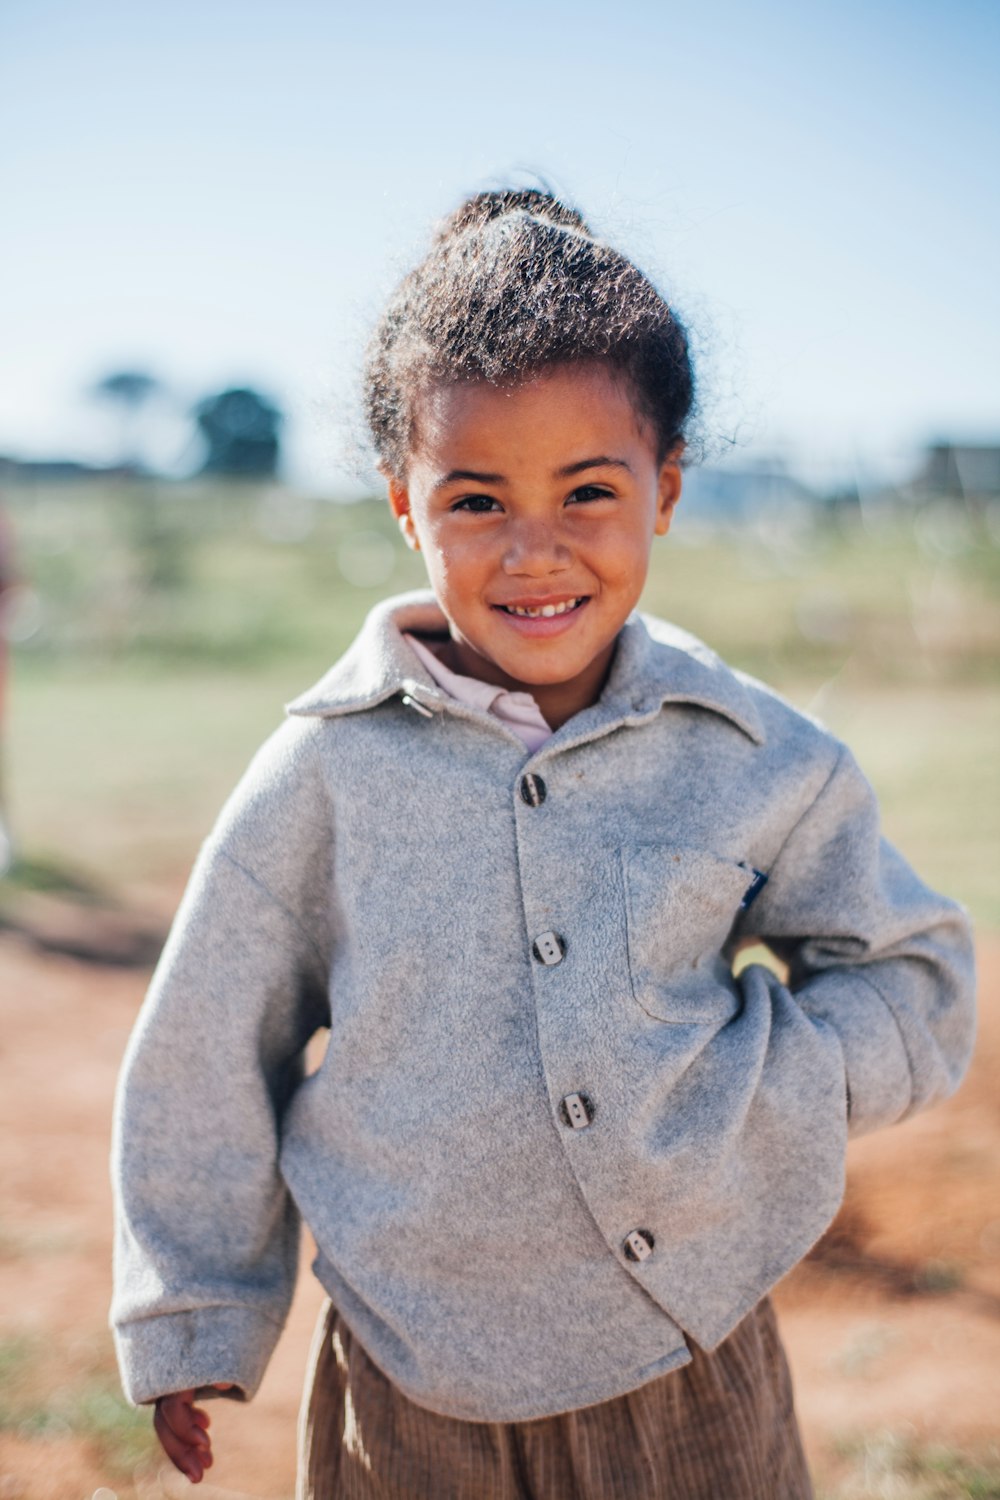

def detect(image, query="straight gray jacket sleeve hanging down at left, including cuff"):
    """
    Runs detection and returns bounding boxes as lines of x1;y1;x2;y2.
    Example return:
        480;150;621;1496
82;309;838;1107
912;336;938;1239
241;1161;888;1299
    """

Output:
111;726;331;1403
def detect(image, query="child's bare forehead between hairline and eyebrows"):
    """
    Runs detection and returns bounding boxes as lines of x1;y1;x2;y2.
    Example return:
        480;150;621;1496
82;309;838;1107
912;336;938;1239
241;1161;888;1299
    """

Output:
412;365;654;473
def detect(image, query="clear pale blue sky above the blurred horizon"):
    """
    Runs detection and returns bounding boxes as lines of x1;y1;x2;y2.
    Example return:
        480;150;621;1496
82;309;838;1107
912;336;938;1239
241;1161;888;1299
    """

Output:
0;0;1000;488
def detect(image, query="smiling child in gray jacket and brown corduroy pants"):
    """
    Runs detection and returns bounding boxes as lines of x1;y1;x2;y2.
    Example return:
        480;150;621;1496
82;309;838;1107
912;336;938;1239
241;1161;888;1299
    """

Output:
112;192;973;1500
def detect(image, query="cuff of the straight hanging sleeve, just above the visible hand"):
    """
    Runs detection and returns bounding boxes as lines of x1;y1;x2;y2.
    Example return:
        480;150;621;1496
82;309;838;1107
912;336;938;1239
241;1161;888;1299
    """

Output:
114;1307;282;1406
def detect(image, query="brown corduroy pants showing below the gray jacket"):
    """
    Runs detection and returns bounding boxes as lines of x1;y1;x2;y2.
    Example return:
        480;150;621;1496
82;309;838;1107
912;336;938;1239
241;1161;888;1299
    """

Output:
298;1298;813;1500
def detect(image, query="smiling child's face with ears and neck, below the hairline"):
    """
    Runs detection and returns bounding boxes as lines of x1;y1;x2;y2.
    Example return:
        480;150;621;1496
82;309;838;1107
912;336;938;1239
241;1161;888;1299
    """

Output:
390;365;681;728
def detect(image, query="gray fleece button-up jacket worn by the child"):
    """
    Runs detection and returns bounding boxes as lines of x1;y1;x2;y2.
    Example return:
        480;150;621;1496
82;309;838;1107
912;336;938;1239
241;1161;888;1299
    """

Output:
112;594;973;1421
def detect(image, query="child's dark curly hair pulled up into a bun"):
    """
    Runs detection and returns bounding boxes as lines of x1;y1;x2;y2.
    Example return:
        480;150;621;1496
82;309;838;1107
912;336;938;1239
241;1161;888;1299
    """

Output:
363;188;694;477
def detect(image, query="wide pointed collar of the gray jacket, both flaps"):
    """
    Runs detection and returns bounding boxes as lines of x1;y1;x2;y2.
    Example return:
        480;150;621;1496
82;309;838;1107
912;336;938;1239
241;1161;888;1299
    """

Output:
286;590;765;746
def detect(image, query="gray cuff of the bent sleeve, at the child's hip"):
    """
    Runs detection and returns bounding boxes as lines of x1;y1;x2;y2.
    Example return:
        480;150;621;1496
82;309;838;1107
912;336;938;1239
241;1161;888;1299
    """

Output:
795;968;913;1136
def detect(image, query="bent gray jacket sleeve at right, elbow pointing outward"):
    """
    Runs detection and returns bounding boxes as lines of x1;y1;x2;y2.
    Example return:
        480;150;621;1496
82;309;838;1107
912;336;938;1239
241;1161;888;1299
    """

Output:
744;747;975;1136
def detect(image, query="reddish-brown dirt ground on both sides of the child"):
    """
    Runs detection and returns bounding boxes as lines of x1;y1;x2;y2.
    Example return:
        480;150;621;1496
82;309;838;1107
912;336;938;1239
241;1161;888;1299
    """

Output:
0;912;1000;1500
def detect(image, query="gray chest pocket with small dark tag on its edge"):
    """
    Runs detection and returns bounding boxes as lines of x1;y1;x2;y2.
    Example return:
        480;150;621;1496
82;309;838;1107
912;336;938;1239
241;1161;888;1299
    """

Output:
622;845;754;1026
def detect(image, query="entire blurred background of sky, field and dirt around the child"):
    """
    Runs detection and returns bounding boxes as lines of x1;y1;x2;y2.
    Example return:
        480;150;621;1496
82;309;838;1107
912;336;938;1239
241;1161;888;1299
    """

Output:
0;0;1000;1500
